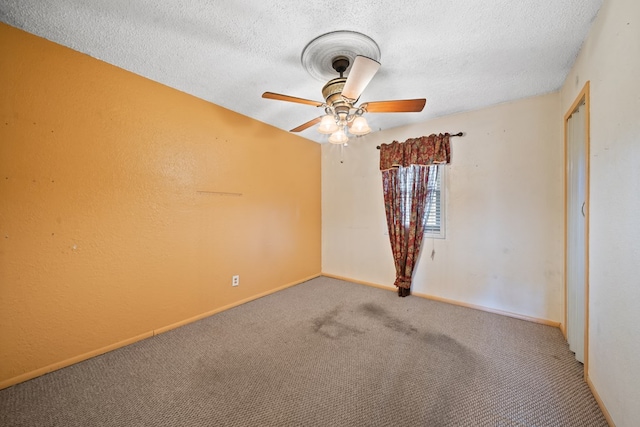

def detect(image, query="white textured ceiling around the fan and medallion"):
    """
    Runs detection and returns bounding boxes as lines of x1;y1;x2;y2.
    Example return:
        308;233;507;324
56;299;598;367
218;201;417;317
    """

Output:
0;0;603;142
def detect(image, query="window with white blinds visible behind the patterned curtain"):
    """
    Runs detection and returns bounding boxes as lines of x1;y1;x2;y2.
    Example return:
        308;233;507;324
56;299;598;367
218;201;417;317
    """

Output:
400;165;445;239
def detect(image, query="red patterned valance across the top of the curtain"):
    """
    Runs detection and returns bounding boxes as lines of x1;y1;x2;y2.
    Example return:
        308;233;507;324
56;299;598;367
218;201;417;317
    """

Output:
380;133;451;170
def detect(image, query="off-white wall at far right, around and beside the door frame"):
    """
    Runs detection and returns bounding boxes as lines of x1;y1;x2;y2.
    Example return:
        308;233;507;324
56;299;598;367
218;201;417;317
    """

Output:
561;0;640;427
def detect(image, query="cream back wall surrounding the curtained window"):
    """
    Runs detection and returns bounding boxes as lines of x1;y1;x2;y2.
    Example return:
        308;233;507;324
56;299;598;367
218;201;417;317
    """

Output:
322;93;564;322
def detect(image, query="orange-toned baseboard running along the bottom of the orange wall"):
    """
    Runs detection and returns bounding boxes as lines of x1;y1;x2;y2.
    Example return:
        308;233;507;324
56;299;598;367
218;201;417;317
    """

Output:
0;274;321;390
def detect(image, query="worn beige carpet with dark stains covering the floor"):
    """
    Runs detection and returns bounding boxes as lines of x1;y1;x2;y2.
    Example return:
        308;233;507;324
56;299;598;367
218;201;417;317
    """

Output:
0;278;607;427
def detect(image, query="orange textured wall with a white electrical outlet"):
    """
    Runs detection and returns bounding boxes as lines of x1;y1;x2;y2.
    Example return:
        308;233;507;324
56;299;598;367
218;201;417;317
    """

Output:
0;24;321;387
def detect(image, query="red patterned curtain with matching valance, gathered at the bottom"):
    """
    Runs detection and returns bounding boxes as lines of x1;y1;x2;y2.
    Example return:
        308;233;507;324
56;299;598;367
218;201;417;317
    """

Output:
380;133;451;297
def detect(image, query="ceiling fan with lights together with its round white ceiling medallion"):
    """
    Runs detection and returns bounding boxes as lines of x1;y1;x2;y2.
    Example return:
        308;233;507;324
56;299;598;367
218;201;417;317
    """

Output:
262;31;426;144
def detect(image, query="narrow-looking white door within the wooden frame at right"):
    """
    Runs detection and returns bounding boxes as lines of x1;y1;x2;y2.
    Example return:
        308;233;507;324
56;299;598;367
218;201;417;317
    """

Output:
566;102;587;363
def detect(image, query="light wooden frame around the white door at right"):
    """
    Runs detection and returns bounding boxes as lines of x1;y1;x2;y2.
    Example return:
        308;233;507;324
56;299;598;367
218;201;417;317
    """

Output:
562;81;591;381
